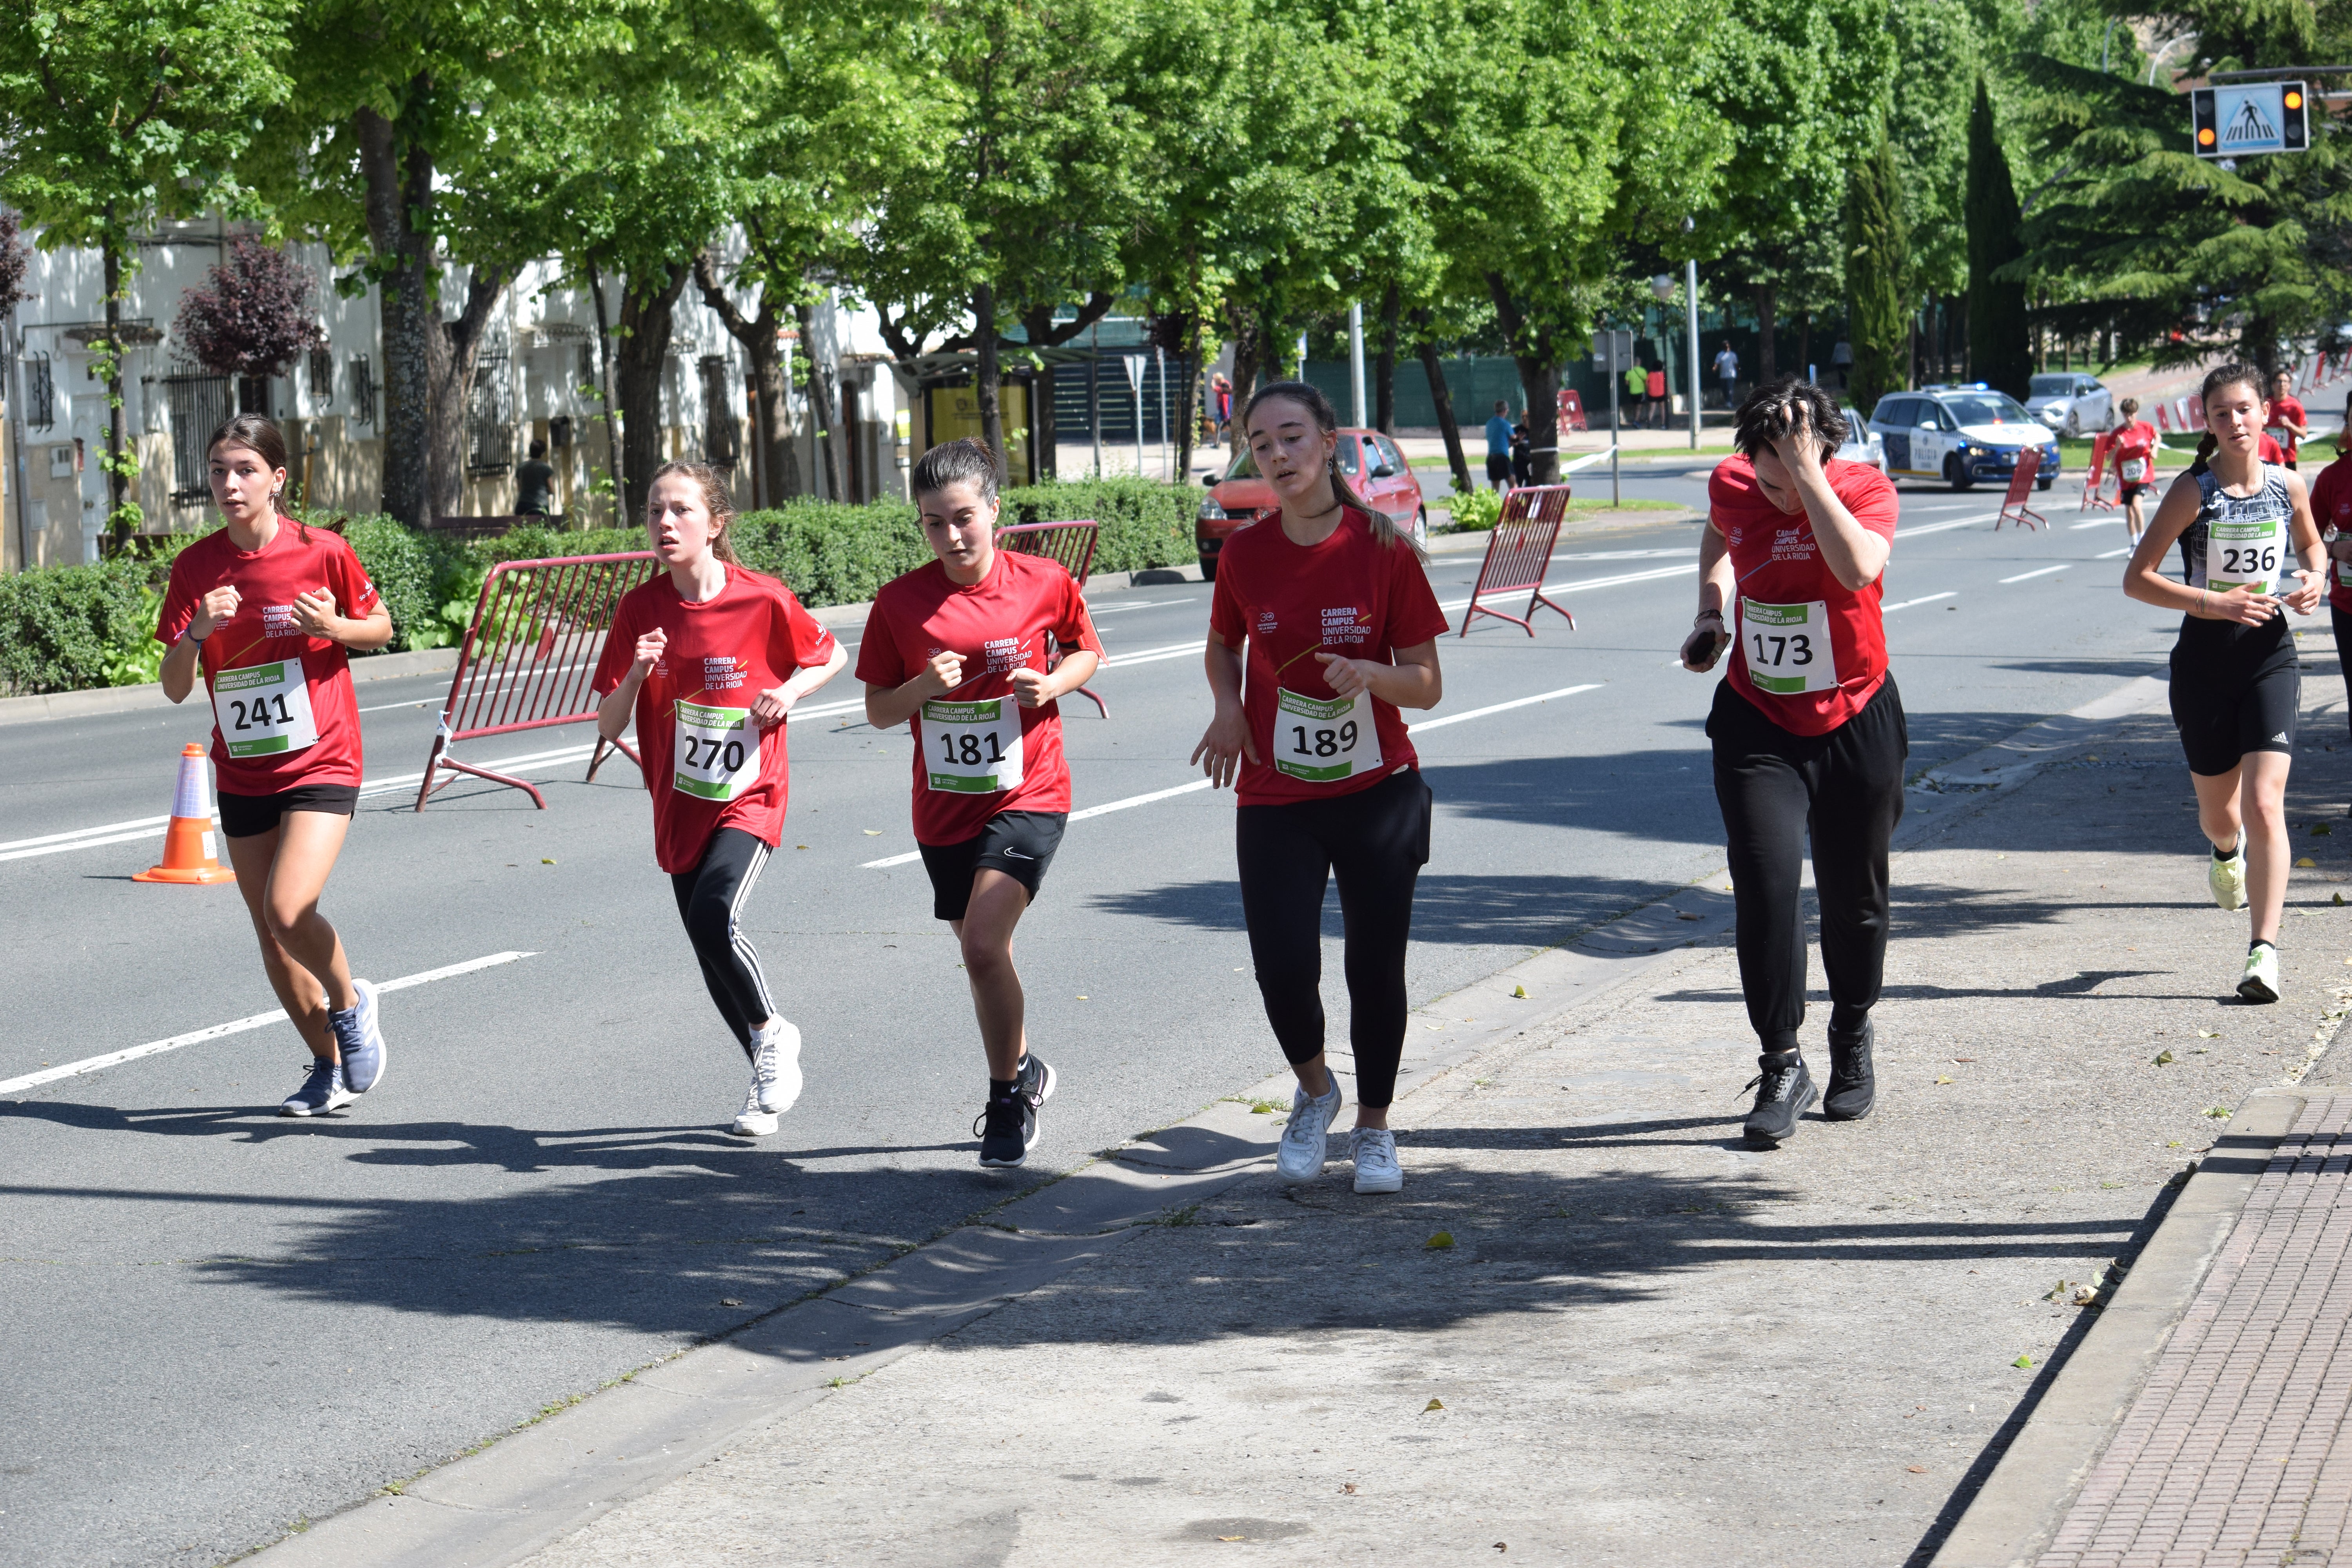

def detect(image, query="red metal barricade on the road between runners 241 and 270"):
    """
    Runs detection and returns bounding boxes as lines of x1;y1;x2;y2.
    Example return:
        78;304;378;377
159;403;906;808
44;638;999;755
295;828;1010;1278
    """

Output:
416;550;654;811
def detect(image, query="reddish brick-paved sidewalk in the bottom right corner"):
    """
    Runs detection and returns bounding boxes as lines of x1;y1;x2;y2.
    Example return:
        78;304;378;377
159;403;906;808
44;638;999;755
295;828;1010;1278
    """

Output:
2037;1096;2352;1568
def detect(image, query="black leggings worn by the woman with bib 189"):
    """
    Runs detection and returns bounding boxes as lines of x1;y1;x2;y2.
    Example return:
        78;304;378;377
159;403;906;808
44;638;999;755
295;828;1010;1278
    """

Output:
1232;769;1430;1110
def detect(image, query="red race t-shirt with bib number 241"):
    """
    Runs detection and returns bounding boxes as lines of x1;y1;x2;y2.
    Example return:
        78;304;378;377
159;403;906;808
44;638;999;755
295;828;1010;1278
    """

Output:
155;517;376;795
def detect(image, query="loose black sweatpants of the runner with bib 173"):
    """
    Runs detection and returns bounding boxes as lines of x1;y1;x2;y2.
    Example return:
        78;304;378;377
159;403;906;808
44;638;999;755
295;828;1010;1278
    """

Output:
1708;675;1910;1051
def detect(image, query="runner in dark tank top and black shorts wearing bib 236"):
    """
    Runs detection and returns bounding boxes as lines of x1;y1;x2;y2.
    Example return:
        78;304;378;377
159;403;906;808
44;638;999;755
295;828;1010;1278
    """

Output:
2124;365;2324;1002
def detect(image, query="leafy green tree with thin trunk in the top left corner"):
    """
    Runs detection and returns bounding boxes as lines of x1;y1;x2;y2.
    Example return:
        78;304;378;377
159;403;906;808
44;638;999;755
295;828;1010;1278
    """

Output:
0;0;287;538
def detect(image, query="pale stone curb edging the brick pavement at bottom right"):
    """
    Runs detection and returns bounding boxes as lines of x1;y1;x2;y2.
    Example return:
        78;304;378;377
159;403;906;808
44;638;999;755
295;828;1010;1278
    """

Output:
1931;1089;2305;1568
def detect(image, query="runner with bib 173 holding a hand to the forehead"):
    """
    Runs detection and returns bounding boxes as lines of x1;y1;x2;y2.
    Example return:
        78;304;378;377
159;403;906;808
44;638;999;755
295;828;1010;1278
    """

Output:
1682;376;1910;1145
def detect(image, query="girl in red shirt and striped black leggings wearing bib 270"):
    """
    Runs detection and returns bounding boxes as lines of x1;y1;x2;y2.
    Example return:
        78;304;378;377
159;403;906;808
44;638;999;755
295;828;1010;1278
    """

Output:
595;463;849;1138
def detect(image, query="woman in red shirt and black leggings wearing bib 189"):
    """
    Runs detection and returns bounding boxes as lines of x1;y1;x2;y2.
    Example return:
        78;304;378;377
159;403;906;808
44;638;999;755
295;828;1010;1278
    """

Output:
1192;381;1446;1192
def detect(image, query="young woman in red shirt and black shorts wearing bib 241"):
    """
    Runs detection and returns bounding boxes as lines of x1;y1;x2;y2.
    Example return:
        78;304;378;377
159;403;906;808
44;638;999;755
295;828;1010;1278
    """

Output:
155;414;393;1117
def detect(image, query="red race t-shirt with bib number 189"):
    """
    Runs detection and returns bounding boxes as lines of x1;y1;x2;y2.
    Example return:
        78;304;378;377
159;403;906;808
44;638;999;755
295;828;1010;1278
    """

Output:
1209;508;1446;806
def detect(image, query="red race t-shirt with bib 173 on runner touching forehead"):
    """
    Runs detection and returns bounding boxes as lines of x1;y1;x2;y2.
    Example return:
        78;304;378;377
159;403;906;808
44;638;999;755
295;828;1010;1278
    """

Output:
1708;456;1898;736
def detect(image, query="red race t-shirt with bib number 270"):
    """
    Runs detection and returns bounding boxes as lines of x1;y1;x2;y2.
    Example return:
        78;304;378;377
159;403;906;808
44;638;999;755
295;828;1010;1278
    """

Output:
595;566;833;872
